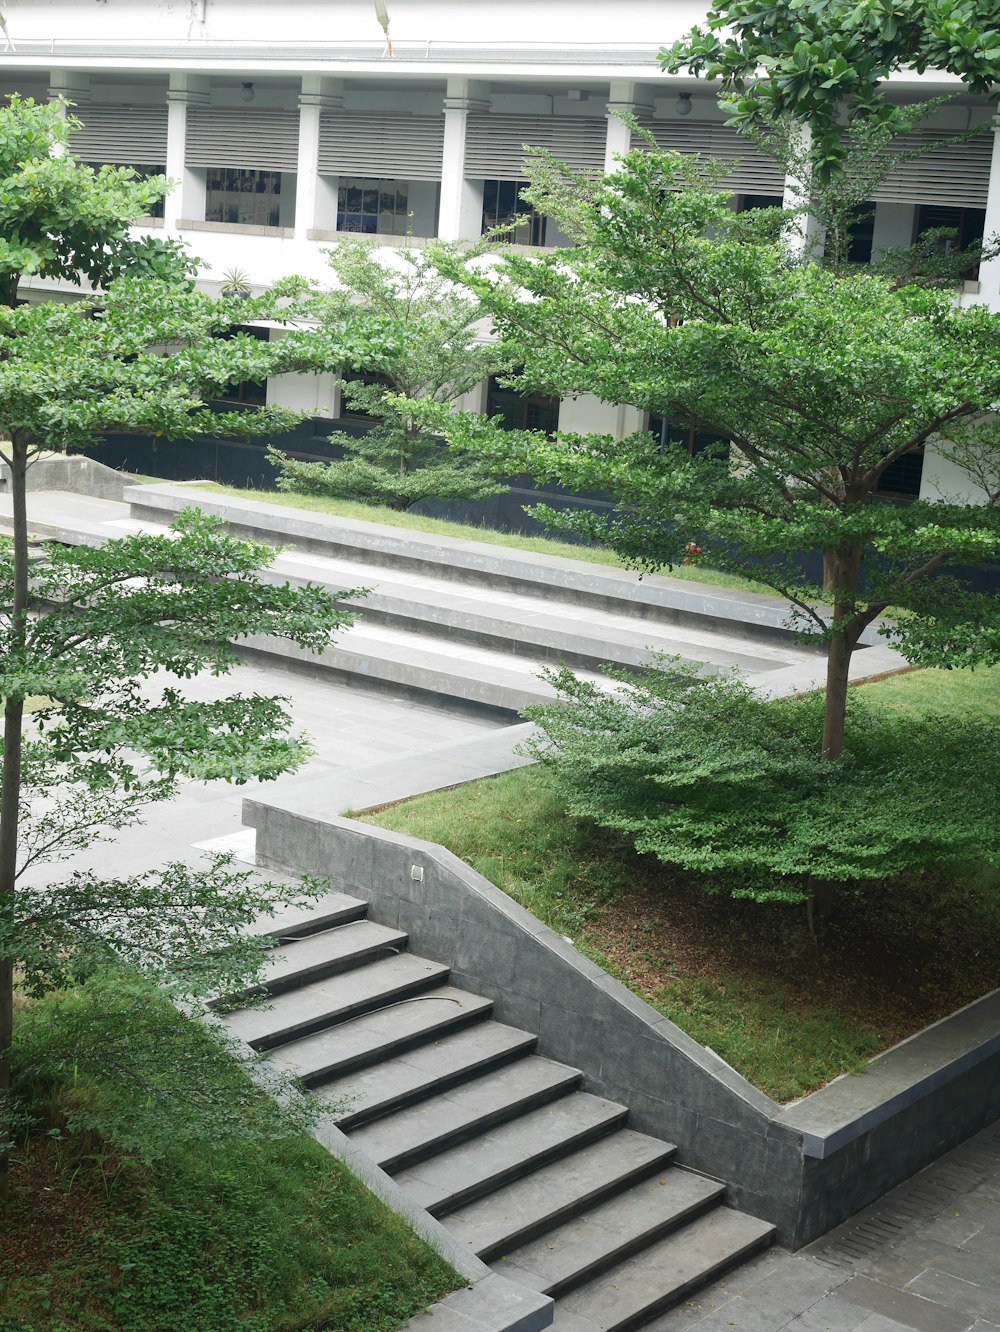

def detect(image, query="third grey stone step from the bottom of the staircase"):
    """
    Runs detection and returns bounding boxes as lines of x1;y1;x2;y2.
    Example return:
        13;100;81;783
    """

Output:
445;1128;676;1263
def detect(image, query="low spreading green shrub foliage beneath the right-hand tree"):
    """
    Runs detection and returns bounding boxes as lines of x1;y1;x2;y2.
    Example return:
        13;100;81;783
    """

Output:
519;662;1000;902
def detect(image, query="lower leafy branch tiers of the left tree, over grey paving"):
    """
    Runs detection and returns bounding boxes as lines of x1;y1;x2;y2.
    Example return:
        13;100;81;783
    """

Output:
0;510;358;872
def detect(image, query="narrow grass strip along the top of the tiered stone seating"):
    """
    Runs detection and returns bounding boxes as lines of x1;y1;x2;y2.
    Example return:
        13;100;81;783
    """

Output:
198;481;775;597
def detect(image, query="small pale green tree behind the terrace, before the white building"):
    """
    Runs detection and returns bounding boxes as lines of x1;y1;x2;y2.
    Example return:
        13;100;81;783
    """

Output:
269;240;507;509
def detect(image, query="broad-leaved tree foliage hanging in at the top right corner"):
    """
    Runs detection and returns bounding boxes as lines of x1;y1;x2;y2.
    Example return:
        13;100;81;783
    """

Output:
660;0;1000;181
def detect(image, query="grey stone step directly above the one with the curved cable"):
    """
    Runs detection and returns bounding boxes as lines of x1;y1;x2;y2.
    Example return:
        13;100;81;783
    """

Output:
224;952;449;1050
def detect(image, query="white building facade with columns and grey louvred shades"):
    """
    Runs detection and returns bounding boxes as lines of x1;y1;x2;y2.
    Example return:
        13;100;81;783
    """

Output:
0;0;1000;496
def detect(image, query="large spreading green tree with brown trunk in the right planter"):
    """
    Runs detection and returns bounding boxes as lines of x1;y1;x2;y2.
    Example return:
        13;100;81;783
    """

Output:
425;152;1000;759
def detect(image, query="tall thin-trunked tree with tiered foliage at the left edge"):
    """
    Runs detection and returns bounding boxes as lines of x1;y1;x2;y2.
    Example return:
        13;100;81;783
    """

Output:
0;99;375;1198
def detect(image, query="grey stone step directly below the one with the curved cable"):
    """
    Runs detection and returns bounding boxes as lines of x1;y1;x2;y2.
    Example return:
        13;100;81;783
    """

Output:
317;1022;538;1131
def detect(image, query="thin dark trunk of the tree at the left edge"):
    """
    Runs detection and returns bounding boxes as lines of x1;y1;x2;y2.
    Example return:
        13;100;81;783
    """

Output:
0;436;28;1200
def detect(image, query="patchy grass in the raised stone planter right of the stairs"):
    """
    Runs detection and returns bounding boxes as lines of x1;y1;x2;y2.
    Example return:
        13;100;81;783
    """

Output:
365;669;1000;1100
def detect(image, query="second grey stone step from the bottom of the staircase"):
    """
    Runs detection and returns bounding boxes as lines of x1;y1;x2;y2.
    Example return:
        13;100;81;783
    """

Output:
494;1167;726;1299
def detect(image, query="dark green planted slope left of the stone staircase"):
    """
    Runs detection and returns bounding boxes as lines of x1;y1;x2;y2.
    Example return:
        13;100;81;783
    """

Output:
0;972;461;1332
